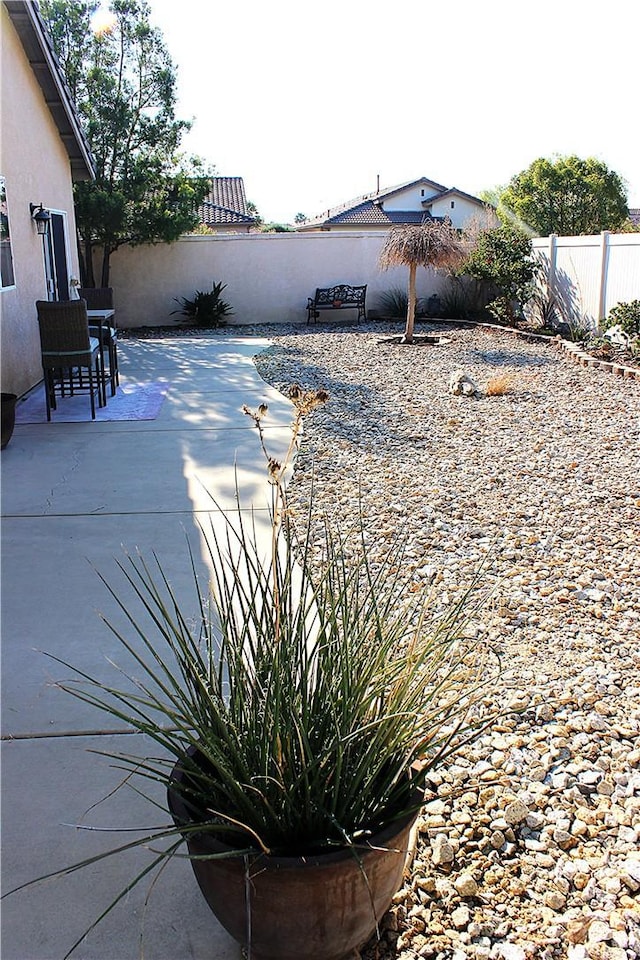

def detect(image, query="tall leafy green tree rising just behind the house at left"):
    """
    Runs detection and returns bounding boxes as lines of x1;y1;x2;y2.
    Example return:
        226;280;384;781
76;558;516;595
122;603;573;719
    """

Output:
40;0;211;286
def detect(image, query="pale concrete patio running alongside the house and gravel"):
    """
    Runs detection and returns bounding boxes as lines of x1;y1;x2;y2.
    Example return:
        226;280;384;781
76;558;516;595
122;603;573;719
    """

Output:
2;336;292;960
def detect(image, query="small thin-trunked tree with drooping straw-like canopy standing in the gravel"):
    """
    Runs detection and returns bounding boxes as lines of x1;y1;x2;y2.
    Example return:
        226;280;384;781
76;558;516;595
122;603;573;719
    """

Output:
378;220;465;343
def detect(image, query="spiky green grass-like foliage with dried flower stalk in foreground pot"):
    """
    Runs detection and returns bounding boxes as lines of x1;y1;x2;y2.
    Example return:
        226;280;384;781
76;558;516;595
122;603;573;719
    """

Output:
6;387;498;952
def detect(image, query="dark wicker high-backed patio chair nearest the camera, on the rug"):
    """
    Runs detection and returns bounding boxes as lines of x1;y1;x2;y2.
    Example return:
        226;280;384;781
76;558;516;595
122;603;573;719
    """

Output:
36;300;107;420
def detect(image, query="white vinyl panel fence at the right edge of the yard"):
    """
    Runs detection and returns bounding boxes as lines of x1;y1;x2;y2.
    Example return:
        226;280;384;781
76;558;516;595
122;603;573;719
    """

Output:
533;231;640;330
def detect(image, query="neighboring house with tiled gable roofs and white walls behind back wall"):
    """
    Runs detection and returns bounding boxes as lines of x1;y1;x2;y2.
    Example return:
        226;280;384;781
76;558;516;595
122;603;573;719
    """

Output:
296;177;498;232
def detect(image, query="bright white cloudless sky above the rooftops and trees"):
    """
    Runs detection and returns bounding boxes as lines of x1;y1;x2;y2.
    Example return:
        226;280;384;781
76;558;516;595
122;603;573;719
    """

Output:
142;0;640;223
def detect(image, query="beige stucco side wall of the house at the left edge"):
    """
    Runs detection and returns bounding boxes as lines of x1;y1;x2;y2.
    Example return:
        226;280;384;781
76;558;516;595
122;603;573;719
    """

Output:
0;4;78;395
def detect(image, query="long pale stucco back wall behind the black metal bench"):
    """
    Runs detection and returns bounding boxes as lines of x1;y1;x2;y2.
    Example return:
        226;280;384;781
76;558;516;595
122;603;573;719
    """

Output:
111;231;444;327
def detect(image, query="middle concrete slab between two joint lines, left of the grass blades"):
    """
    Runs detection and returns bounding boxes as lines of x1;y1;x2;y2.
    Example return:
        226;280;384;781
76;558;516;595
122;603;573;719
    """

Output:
2;513;268;737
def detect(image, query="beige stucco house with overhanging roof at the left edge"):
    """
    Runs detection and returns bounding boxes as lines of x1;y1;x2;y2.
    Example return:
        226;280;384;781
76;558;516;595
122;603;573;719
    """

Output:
0;0;94;395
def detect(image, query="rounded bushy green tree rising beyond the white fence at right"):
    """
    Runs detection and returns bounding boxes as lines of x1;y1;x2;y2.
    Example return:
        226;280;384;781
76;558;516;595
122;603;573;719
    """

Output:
498;156;629;236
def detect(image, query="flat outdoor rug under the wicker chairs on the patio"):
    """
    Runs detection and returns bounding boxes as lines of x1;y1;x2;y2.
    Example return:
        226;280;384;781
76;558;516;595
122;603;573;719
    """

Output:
16;383;168;423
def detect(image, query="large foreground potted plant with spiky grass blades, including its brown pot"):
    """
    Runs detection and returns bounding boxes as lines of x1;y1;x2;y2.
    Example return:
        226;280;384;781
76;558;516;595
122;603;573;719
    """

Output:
5;387;502;960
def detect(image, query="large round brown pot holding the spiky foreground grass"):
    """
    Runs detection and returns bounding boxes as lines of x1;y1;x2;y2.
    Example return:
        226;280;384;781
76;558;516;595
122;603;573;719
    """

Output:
168;752;417;960
